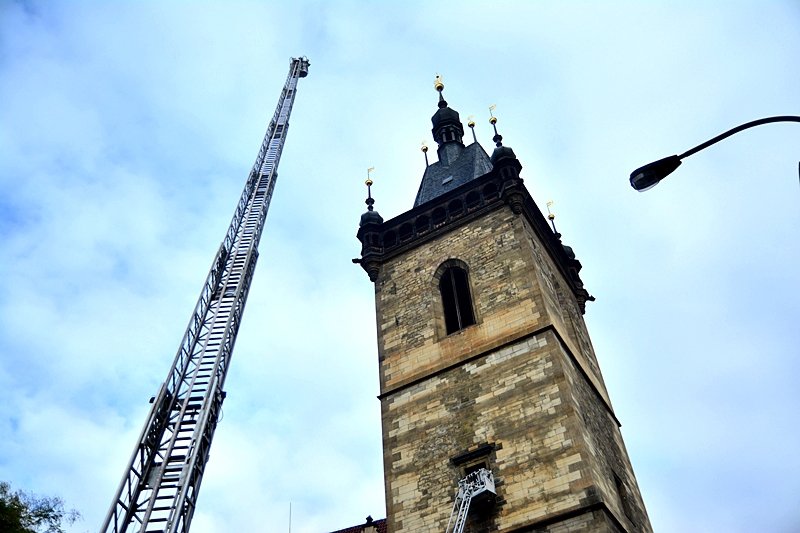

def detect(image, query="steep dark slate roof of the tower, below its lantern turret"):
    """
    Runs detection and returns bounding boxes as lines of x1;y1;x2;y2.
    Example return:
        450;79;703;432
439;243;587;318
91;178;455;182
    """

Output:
414;142;492;207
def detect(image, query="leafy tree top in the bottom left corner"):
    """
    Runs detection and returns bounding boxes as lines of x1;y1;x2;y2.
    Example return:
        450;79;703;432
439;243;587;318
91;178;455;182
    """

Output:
0;481;80;533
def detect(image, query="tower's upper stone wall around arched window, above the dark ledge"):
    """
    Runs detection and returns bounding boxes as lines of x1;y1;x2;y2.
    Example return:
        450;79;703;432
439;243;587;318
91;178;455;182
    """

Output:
375;207;608;403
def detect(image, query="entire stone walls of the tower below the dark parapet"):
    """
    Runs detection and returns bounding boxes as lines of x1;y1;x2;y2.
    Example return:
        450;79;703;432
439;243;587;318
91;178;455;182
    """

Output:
375;203;649;533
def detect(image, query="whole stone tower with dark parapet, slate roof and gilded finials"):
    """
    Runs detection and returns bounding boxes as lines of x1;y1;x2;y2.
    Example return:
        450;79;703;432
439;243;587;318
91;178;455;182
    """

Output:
354;80;652;533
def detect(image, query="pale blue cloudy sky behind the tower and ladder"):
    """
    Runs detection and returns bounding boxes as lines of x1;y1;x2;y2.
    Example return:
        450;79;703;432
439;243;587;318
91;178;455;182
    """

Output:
0;0;800;533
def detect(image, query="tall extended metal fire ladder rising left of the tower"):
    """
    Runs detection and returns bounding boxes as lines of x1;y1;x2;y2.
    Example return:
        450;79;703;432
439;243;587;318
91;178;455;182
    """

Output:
101;57;310;533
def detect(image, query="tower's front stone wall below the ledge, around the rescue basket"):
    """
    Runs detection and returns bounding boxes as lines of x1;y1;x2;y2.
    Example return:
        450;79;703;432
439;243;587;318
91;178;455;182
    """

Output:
382;335;591;533
